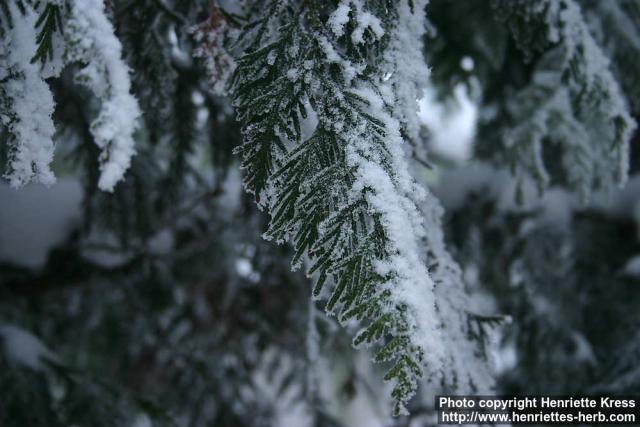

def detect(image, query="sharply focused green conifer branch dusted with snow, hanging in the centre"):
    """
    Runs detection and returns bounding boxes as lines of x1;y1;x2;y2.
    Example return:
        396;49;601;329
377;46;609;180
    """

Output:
225;1;450;413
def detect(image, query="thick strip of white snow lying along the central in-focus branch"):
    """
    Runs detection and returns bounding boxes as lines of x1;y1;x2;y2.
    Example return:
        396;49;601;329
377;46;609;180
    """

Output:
345;82;443;371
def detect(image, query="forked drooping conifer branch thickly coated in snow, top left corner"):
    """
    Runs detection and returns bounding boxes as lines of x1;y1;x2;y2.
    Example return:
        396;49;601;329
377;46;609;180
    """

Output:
1;0;140;191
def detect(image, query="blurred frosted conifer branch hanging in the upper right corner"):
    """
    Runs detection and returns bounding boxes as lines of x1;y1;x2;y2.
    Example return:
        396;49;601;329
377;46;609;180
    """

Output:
494;0;636;199
